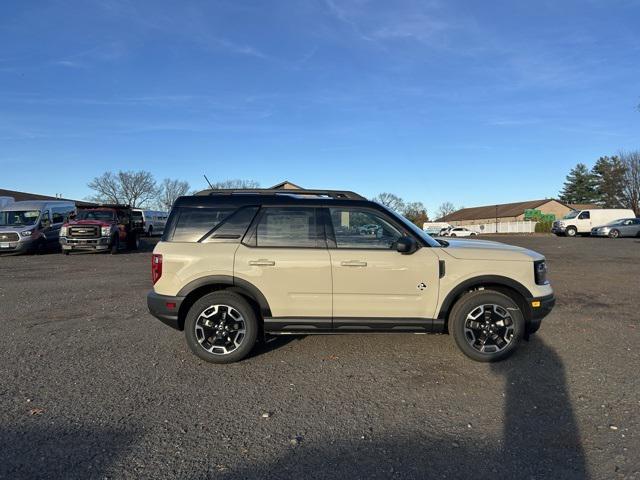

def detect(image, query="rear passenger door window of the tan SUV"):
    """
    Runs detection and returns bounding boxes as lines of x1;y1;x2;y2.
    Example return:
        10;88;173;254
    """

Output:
256;207;319;247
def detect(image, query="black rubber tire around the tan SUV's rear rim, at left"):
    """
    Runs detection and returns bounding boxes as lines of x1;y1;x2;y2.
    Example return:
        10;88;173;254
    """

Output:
184;290;258;363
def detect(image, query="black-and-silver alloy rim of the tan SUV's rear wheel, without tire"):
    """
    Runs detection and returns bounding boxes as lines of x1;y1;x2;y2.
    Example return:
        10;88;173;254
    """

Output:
195;305;247;355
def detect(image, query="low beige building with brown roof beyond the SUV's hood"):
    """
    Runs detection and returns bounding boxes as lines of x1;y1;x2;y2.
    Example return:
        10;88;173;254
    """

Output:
438;198;584;226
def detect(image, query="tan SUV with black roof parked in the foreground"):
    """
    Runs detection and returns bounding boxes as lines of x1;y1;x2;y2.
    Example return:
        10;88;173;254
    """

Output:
147;190;555;363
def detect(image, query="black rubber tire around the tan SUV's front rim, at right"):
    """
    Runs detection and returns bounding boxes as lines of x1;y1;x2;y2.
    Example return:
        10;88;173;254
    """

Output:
448;290;525;362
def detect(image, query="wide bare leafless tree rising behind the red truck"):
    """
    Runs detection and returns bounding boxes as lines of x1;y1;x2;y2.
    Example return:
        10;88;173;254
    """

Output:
88;170;158;207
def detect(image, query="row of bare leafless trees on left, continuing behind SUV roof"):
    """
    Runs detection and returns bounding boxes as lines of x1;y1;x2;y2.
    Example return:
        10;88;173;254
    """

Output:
87;170;260;211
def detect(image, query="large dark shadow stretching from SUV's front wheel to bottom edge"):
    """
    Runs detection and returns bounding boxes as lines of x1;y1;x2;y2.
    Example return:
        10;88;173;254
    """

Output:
222;338;589;480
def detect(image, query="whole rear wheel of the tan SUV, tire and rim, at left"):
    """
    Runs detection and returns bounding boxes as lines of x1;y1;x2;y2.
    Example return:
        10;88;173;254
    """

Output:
184;291;258;363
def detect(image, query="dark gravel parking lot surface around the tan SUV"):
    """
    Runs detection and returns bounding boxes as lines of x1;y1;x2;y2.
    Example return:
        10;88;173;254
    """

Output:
0;236;640;479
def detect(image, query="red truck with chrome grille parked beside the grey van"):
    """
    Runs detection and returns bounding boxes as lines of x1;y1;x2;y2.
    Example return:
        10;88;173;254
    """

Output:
60;205;142;255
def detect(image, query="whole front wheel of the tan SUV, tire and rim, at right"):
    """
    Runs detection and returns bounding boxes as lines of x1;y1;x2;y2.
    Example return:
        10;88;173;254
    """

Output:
449;290;525;362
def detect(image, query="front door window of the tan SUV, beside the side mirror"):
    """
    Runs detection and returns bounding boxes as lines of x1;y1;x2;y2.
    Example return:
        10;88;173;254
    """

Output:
329;208;402;249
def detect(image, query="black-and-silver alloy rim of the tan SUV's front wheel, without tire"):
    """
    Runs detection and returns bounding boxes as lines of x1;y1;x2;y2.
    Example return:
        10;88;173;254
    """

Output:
464;304;515;353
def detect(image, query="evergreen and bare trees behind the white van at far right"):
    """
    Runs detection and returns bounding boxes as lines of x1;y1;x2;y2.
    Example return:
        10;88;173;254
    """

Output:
559;150;640;215
